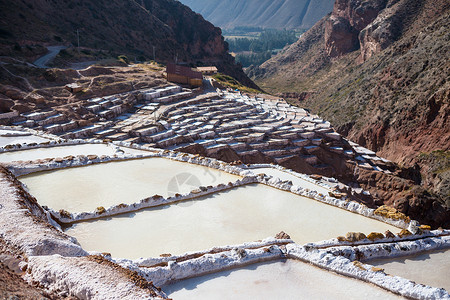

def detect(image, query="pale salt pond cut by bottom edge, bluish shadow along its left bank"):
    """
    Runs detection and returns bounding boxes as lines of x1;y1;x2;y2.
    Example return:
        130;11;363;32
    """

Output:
162;260;400;300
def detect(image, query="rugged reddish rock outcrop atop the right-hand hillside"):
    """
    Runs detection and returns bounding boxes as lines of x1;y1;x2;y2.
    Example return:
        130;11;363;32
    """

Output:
325;0;446;63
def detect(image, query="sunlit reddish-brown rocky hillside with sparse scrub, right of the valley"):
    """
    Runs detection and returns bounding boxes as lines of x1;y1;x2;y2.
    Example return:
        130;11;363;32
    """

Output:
248;0;450;226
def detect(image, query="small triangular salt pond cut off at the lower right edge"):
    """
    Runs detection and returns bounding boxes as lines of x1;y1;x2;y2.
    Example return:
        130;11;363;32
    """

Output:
367;250;450;291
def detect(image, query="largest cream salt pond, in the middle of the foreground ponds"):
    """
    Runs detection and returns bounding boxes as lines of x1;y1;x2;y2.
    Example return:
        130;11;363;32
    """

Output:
66;184;399;258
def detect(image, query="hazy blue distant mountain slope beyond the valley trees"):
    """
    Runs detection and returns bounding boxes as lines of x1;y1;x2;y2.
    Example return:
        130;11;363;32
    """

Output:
180;0;334;29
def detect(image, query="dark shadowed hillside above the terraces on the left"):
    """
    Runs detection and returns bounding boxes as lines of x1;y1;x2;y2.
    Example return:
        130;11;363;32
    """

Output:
0;0;251;84
